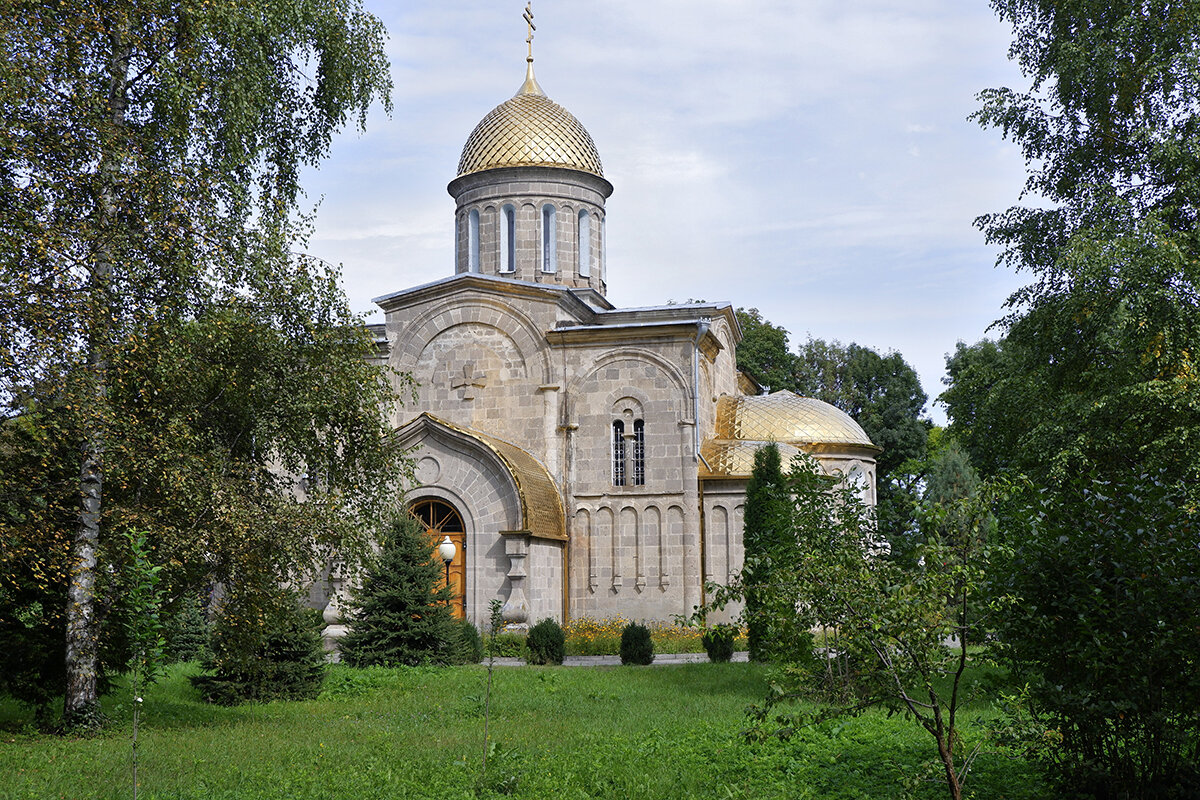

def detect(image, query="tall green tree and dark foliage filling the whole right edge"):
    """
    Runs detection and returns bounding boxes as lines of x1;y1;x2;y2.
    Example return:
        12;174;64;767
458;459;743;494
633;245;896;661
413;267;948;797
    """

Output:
960;6;1200;798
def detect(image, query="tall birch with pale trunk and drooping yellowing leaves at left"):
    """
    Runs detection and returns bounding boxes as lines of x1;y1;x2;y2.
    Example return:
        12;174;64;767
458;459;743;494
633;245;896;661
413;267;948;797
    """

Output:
0;0;400;724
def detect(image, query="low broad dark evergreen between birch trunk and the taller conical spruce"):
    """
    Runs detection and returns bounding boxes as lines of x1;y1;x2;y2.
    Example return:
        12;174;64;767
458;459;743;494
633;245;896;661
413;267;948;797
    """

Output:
192;587;325;705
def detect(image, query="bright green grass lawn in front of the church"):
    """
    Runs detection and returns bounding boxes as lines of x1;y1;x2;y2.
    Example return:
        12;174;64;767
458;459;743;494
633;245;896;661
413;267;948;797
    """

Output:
0;663;1049;800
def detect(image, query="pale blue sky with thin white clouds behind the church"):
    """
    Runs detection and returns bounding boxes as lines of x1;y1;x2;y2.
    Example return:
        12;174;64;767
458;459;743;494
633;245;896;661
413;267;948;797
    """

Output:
297;0;1028;423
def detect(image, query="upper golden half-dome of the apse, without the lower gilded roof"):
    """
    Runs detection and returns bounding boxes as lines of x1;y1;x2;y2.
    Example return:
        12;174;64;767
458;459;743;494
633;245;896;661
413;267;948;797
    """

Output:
715;391;875;447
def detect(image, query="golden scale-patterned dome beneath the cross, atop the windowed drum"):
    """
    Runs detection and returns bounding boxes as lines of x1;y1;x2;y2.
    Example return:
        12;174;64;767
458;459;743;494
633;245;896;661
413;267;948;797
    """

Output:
458;62;604;178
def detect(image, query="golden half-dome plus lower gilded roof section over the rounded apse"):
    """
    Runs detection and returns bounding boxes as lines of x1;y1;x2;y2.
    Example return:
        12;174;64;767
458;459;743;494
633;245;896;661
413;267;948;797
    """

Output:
701;391;880;477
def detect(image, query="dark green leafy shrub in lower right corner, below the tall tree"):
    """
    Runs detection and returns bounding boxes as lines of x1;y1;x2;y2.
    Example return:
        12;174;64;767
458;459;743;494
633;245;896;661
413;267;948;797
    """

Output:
998;475;1200;799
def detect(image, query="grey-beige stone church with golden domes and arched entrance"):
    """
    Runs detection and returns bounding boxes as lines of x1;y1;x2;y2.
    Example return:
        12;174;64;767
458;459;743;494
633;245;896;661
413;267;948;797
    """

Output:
326;43;878;624
